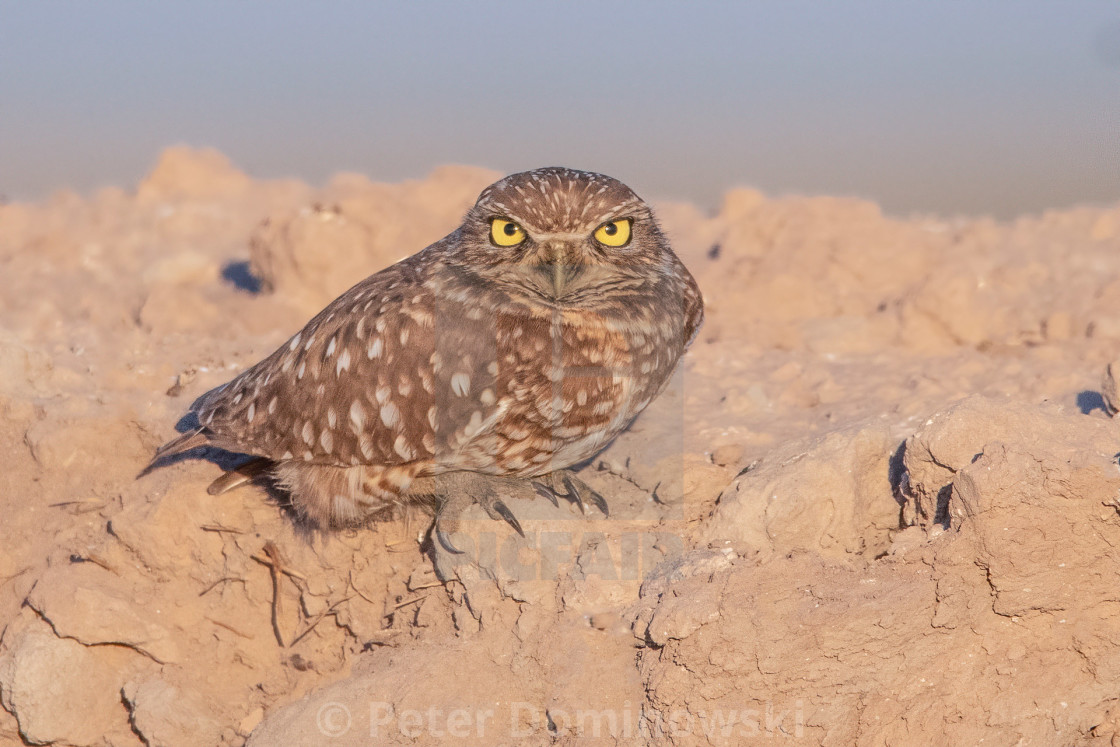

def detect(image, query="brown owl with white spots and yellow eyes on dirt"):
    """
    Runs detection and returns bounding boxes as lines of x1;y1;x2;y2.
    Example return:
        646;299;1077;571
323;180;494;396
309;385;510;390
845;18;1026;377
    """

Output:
153;168;703;539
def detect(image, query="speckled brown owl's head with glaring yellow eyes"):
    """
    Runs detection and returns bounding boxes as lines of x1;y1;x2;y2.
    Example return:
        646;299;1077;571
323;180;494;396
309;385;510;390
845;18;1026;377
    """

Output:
448;167;675;302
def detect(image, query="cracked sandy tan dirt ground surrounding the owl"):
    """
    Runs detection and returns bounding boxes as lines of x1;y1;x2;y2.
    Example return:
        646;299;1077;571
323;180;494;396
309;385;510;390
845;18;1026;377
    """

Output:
0;149;1120;747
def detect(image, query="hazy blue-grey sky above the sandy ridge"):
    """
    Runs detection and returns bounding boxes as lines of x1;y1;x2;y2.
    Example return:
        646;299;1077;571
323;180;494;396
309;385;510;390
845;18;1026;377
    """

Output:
0;0;1120;216
